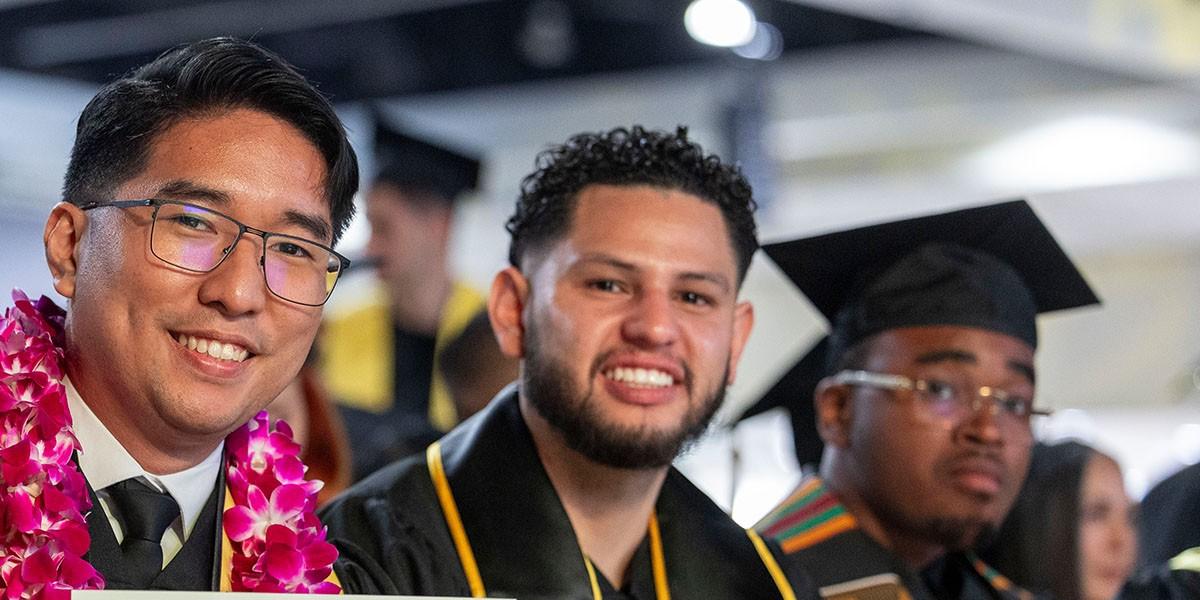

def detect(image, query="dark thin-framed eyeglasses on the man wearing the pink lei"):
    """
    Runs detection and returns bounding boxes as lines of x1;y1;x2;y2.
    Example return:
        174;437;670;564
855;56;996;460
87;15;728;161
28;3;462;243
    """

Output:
82;199;350;306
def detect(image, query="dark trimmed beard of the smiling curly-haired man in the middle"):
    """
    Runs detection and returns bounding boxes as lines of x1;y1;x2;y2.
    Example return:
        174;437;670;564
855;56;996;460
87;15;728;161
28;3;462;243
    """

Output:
521;324;728;469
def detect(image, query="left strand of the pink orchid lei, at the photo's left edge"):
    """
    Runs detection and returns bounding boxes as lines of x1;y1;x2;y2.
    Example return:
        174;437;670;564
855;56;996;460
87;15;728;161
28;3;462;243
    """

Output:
0;290;104;599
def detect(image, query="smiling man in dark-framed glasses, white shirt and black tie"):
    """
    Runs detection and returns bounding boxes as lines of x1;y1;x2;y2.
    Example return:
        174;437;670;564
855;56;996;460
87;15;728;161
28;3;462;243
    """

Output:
15;38;358;592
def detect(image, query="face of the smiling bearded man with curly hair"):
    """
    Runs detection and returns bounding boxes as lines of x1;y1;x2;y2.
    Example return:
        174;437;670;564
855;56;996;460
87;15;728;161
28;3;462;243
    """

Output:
504;185;752;468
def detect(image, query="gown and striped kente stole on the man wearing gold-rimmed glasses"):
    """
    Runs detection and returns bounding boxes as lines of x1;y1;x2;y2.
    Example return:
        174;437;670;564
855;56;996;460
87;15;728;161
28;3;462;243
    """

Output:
755;476;1033;600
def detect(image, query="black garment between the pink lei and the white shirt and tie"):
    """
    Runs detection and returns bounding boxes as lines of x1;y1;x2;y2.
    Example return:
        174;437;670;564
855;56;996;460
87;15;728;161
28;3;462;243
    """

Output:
83;468;224;592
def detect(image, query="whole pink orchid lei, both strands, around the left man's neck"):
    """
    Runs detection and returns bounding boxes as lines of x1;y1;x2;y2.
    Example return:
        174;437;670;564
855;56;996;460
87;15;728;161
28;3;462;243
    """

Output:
0;290;341;600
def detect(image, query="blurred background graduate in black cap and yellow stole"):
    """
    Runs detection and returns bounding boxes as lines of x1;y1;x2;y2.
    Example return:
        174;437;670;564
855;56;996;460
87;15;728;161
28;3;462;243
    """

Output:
319;113;508;480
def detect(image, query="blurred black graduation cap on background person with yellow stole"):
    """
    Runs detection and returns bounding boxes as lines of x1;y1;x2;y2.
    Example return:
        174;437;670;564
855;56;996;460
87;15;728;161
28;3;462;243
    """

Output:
374;112;479;204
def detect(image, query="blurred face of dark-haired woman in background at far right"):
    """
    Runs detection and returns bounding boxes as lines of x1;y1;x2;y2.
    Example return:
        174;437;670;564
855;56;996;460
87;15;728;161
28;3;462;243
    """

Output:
1079;454;1138;600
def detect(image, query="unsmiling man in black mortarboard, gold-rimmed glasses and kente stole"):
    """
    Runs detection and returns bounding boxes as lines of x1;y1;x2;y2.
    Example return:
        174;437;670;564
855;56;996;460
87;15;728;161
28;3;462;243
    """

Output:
756;202;1098;599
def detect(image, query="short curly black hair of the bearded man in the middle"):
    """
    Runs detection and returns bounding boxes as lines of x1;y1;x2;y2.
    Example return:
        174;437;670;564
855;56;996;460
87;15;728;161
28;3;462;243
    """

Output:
506;125;758;284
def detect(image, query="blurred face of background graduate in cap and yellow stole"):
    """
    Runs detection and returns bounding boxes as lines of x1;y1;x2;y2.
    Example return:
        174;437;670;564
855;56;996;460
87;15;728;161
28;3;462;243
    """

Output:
366;182;451;298
